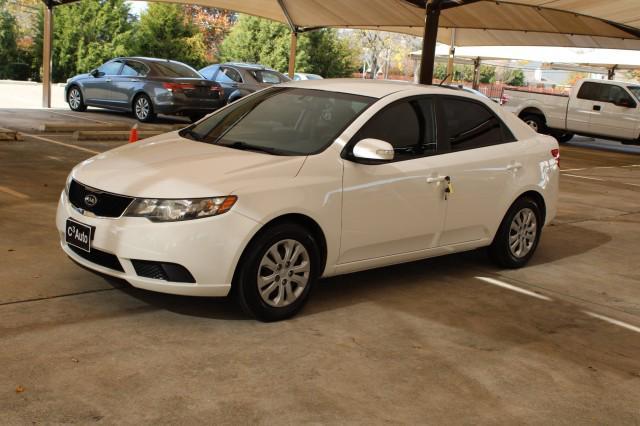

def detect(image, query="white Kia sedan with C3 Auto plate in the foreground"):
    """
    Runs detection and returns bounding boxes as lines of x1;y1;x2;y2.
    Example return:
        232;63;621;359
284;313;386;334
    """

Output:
56;80;559;321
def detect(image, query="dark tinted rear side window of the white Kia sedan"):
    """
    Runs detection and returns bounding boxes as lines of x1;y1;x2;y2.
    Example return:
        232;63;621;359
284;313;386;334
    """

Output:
442;97;515;152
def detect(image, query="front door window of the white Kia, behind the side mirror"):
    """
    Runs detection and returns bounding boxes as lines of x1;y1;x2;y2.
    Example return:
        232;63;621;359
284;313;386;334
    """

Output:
355;98;437;161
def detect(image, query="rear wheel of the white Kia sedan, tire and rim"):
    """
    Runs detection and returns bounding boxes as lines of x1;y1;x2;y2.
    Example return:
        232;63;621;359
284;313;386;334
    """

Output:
489;197;542;269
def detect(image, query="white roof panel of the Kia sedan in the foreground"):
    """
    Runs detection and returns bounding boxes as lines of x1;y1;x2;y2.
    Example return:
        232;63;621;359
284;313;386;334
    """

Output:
278;78;464;99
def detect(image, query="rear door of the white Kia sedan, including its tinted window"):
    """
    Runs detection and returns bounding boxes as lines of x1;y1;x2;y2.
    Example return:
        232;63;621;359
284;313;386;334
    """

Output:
438;96;526;246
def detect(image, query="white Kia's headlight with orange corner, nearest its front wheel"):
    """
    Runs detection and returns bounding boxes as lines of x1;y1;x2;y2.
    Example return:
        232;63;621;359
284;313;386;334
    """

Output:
124;195;238;222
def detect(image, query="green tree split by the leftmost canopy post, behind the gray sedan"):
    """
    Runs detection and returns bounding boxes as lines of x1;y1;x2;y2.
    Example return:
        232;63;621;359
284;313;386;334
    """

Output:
34;0;132;82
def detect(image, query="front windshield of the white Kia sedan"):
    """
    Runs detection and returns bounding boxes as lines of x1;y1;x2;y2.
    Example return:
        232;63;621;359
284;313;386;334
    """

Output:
181;87;375;155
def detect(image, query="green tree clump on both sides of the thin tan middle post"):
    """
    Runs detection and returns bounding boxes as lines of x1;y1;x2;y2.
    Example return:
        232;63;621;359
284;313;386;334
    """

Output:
220;15;355;77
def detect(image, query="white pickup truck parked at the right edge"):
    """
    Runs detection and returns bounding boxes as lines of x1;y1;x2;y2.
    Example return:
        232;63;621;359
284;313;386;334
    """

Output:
503;80;640;143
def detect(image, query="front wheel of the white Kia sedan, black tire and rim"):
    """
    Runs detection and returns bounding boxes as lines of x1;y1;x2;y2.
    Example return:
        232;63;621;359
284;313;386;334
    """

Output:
233;223;320;322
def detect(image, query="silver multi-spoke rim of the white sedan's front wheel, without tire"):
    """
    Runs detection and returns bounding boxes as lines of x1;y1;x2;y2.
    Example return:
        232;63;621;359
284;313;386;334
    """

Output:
257;239;311;308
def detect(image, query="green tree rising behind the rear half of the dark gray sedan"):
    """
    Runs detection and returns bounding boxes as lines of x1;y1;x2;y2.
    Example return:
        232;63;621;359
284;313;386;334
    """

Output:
132;3;207;68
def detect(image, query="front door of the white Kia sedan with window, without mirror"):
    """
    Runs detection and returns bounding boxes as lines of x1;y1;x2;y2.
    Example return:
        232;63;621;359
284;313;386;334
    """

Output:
339;97;446;264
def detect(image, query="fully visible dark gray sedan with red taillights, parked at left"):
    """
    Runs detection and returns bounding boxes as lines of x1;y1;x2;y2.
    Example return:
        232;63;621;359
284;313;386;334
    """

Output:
65;57;224;122
